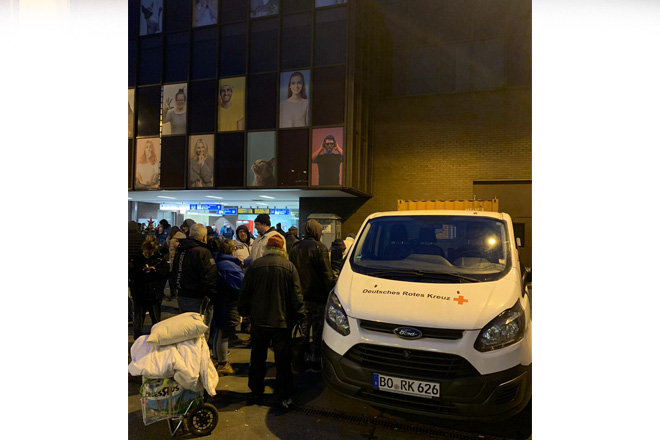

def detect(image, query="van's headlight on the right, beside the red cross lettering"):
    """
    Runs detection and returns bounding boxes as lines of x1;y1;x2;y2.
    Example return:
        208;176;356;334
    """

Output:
474;301;525;352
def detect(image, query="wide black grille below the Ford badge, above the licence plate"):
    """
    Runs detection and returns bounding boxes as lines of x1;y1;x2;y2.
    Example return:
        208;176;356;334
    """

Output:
346;344;479;380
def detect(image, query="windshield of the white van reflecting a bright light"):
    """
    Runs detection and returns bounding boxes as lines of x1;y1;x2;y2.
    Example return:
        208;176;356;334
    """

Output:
350;215;511;282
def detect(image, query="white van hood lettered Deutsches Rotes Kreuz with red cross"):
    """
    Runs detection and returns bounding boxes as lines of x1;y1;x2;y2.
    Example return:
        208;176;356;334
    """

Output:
335;270;520;330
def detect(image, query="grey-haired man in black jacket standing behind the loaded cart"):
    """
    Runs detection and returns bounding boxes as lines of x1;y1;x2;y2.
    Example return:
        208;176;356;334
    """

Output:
172;223;218;340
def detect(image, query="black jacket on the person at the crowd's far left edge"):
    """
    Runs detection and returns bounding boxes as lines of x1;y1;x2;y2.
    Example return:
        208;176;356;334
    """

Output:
128;253;169;301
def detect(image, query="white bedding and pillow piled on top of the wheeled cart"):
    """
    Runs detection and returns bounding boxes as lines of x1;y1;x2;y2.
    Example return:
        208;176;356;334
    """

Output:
128;312;218;396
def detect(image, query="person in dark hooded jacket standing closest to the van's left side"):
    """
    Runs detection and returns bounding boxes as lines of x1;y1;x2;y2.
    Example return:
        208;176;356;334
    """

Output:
289;220;335;373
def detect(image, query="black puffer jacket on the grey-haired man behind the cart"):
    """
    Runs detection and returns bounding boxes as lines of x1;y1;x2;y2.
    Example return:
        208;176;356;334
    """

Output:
172;238;218;300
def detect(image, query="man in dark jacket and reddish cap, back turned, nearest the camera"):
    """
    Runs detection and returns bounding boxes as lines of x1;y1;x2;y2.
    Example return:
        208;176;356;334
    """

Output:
238;234;305;408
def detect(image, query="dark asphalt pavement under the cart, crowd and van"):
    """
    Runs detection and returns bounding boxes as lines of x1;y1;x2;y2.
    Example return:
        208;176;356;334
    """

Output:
128;300;531;440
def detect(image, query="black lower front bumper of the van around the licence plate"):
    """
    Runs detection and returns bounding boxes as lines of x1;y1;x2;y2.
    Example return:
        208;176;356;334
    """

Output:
321;341;532;421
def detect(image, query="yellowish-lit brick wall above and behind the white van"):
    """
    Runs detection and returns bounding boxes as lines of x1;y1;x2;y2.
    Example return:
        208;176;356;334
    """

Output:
340;87;532;236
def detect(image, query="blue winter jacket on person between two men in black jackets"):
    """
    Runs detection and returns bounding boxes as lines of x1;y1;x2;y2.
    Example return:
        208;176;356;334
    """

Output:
213;253;243;328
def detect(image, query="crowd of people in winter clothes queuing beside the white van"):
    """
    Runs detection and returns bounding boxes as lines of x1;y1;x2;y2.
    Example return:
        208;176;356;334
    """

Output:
128;214;356;408
